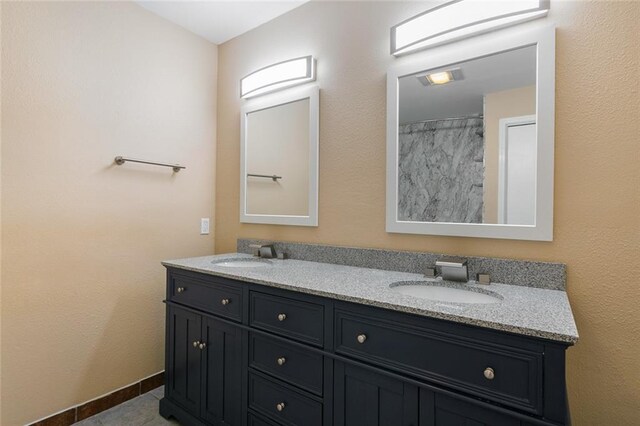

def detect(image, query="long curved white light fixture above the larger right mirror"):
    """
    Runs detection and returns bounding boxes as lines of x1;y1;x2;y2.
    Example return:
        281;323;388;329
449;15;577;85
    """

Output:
391;0;550;56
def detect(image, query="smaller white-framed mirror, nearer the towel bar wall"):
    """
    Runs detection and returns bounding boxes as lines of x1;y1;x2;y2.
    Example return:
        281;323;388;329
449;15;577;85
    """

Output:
240;86;319;226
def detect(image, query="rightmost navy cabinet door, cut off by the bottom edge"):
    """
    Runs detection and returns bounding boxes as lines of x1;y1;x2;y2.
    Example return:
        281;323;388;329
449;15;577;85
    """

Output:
420;389;523;426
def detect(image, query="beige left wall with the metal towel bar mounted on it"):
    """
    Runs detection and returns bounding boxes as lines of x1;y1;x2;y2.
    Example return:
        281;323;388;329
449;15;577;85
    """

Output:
0;2;218;426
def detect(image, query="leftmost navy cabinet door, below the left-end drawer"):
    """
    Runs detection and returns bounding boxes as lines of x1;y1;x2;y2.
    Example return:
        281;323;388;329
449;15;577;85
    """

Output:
165;306;202;413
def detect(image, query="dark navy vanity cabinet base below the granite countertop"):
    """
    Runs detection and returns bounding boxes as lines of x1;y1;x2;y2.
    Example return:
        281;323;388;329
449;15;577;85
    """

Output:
160;268;569;426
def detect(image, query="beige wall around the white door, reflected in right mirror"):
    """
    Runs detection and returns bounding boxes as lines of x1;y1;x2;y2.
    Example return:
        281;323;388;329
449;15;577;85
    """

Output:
483;86;536;223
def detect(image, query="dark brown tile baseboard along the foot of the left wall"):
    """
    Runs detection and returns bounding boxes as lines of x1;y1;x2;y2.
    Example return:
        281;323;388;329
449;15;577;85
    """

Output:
29;371;164;426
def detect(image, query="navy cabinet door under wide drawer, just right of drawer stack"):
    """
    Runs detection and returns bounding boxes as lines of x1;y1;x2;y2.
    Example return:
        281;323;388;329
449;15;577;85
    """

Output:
334;362;418;426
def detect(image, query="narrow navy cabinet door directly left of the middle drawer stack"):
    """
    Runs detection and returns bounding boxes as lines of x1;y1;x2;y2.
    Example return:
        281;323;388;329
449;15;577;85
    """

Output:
202;317;242;426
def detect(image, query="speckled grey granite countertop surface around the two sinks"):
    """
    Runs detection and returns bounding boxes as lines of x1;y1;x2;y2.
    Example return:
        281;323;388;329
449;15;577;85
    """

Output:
162;253;578;344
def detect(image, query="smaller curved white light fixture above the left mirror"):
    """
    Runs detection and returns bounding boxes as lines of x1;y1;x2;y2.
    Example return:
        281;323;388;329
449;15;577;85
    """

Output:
240;55;316;98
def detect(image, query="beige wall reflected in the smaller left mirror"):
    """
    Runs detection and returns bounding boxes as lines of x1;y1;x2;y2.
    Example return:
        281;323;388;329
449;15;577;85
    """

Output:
246;99;309;216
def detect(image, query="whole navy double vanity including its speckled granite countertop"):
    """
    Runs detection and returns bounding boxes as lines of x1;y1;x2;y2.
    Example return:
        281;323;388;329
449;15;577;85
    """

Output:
160;246;577;426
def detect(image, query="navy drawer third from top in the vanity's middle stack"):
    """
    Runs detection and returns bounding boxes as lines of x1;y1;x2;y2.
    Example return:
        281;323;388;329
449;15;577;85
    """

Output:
249;373;322;426
